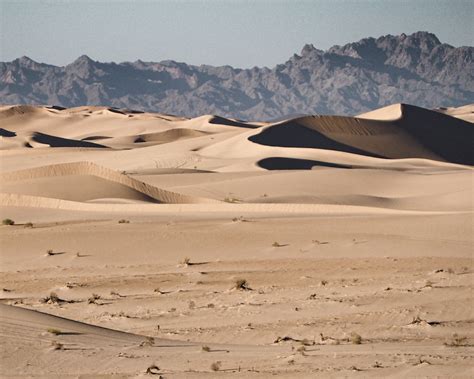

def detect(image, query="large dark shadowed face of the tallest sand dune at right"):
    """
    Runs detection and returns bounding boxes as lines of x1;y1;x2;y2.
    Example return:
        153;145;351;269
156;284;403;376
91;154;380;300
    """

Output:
248;104;474;165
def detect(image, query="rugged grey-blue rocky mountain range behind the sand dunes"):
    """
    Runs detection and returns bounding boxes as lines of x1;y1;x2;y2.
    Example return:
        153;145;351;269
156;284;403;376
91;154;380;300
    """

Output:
0;32;474;120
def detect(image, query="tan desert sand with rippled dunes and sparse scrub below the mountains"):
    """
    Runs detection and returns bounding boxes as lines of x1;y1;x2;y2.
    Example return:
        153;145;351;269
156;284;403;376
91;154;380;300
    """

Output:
0;104;474;378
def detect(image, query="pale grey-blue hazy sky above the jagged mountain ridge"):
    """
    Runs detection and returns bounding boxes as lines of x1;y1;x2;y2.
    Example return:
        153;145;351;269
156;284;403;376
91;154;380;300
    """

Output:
0;0;474;67
